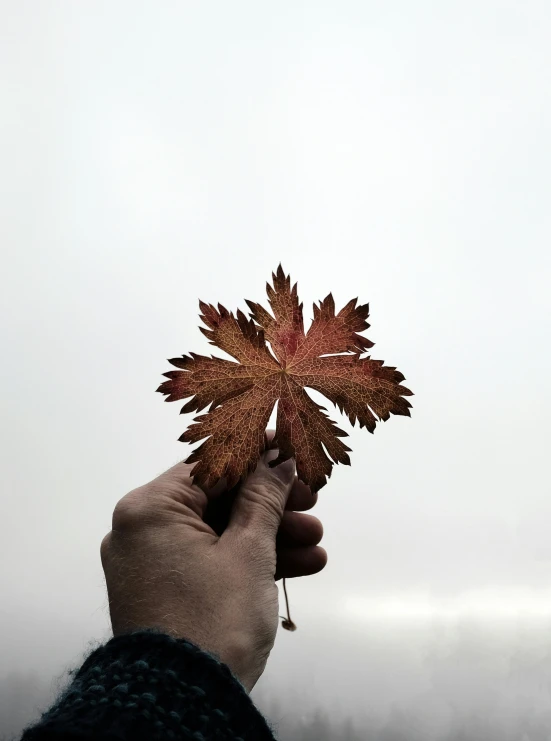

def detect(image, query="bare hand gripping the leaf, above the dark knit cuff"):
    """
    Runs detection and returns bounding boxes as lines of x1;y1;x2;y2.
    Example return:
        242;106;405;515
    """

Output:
101;442;327;692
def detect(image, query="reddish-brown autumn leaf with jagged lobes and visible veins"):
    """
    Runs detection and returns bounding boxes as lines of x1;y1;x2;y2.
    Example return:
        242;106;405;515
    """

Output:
157;265;412;491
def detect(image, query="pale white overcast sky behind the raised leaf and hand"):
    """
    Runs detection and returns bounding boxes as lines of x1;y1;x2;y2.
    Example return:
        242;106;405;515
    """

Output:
0;0;551;736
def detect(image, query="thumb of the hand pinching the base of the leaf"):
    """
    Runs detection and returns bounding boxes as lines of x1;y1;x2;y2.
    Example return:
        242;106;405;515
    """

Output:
227;450;296;540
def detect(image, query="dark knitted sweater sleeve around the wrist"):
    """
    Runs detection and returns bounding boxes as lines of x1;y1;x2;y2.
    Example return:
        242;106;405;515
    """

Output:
21;630;274;741
